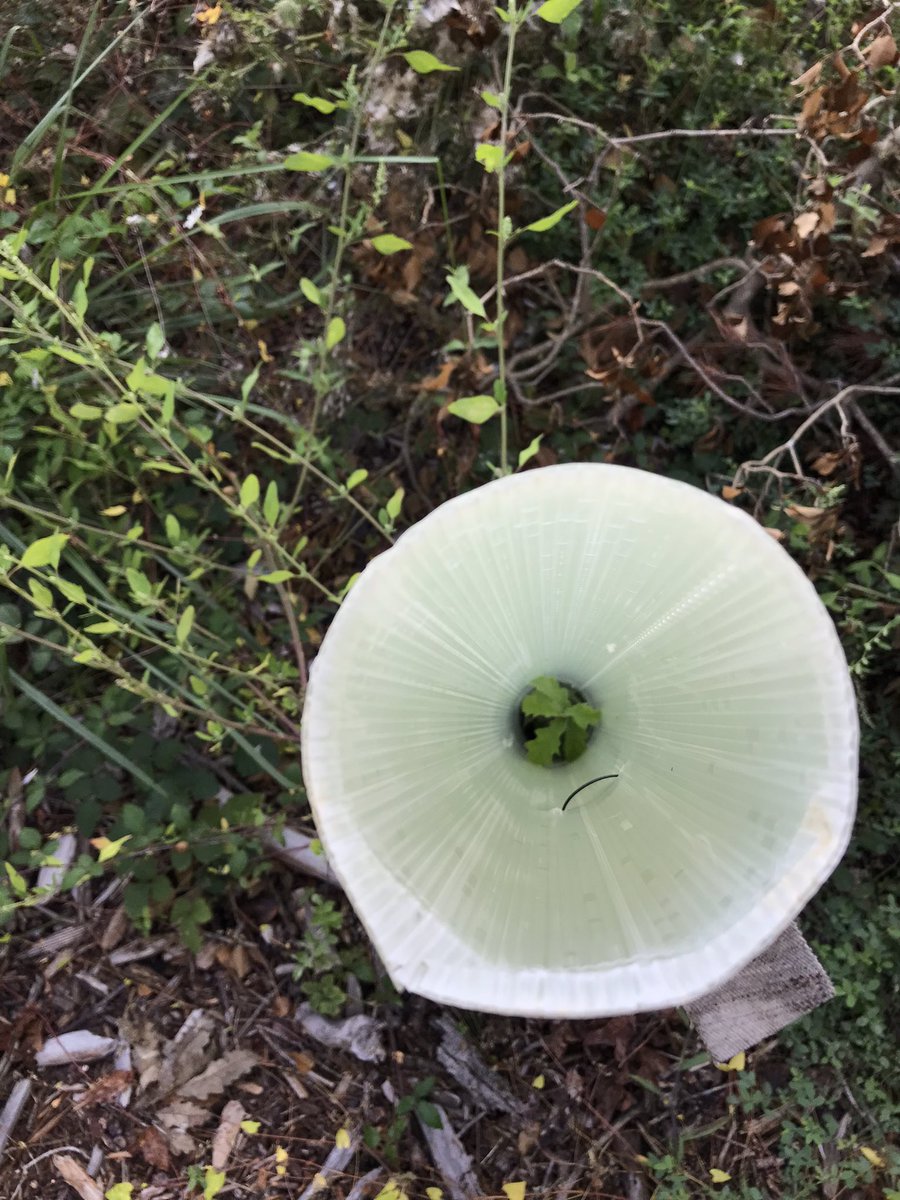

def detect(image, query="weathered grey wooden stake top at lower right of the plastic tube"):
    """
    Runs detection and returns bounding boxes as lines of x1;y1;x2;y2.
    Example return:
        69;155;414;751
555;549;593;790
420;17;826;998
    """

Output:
685;925;834;1062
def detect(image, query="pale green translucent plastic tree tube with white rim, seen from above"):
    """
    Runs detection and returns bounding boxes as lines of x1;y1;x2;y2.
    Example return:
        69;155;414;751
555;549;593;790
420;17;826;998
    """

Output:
302;464;858;1016
